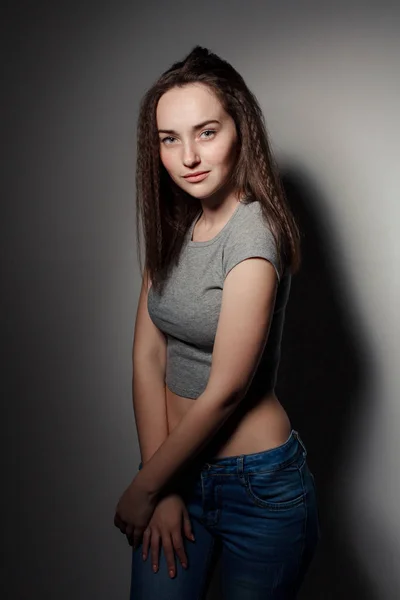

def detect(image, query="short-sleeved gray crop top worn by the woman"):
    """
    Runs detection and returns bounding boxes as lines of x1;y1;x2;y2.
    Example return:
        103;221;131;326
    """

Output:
147;200;291;398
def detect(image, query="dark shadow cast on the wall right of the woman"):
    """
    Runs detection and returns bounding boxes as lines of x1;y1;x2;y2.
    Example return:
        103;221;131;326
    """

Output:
207;170;377;600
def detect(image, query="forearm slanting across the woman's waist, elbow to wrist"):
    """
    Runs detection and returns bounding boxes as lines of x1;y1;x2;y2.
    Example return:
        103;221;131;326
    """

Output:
136;389;239;495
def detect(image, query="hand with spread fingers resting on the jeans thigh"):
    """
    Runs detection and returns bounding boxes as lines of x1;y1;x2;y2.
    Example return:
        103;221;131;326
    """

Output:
142;493;194;577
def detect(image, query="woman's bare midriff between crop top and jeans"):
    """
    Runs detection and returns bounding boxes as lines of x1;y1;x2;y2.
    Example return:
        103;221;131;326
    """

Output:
165;386;292;458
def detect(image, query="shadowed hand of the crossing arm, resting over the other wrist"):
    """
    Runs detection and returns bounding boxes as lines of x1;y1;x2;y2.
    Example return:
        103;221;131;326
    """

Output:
114;479;158;547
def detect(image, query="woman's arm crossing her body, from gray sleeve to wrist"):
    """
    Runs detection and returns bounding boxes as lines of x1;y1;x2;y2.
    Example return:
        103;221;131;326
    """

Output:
136;258;277;495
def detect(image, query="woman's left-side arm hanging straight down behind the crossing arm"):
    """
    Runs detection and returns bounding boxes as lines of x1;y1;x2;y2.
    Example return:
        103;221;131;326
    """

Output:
132;269;168;465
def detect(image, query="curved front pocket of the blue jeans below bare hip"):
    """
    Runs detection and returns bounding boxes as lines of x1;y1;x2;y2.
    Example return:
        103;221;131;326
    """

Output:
245;463;306;510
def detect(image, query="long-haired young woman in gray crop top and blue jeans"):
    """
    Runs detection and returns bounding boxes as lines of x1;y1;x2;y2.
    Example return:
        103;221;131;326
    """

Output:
114;46;320;600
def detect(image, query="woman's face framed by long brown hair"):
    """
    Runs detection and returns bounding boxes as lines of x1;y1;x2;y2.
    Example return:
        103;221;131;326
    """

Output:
156;83;238;198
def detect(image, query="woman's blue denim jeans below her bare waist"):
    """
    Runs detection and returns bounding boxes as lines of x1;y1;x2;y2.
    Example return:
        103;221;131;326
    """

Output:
130;429;320;600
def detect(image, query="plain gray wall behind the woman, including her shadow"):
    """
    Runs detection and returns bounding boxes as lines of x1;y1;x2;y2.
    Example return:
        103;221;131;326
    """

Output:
0;0;400;600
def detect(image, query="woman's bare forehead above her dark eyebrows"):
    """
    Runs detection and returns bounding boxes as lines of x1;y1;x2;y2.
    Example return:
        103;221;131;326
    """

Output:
156;84;225;129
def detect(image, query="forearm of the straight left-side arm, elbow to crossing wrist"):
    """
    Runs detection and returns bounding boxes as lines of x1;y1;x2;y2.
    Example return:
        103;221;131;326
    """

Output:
132;358;168;465
